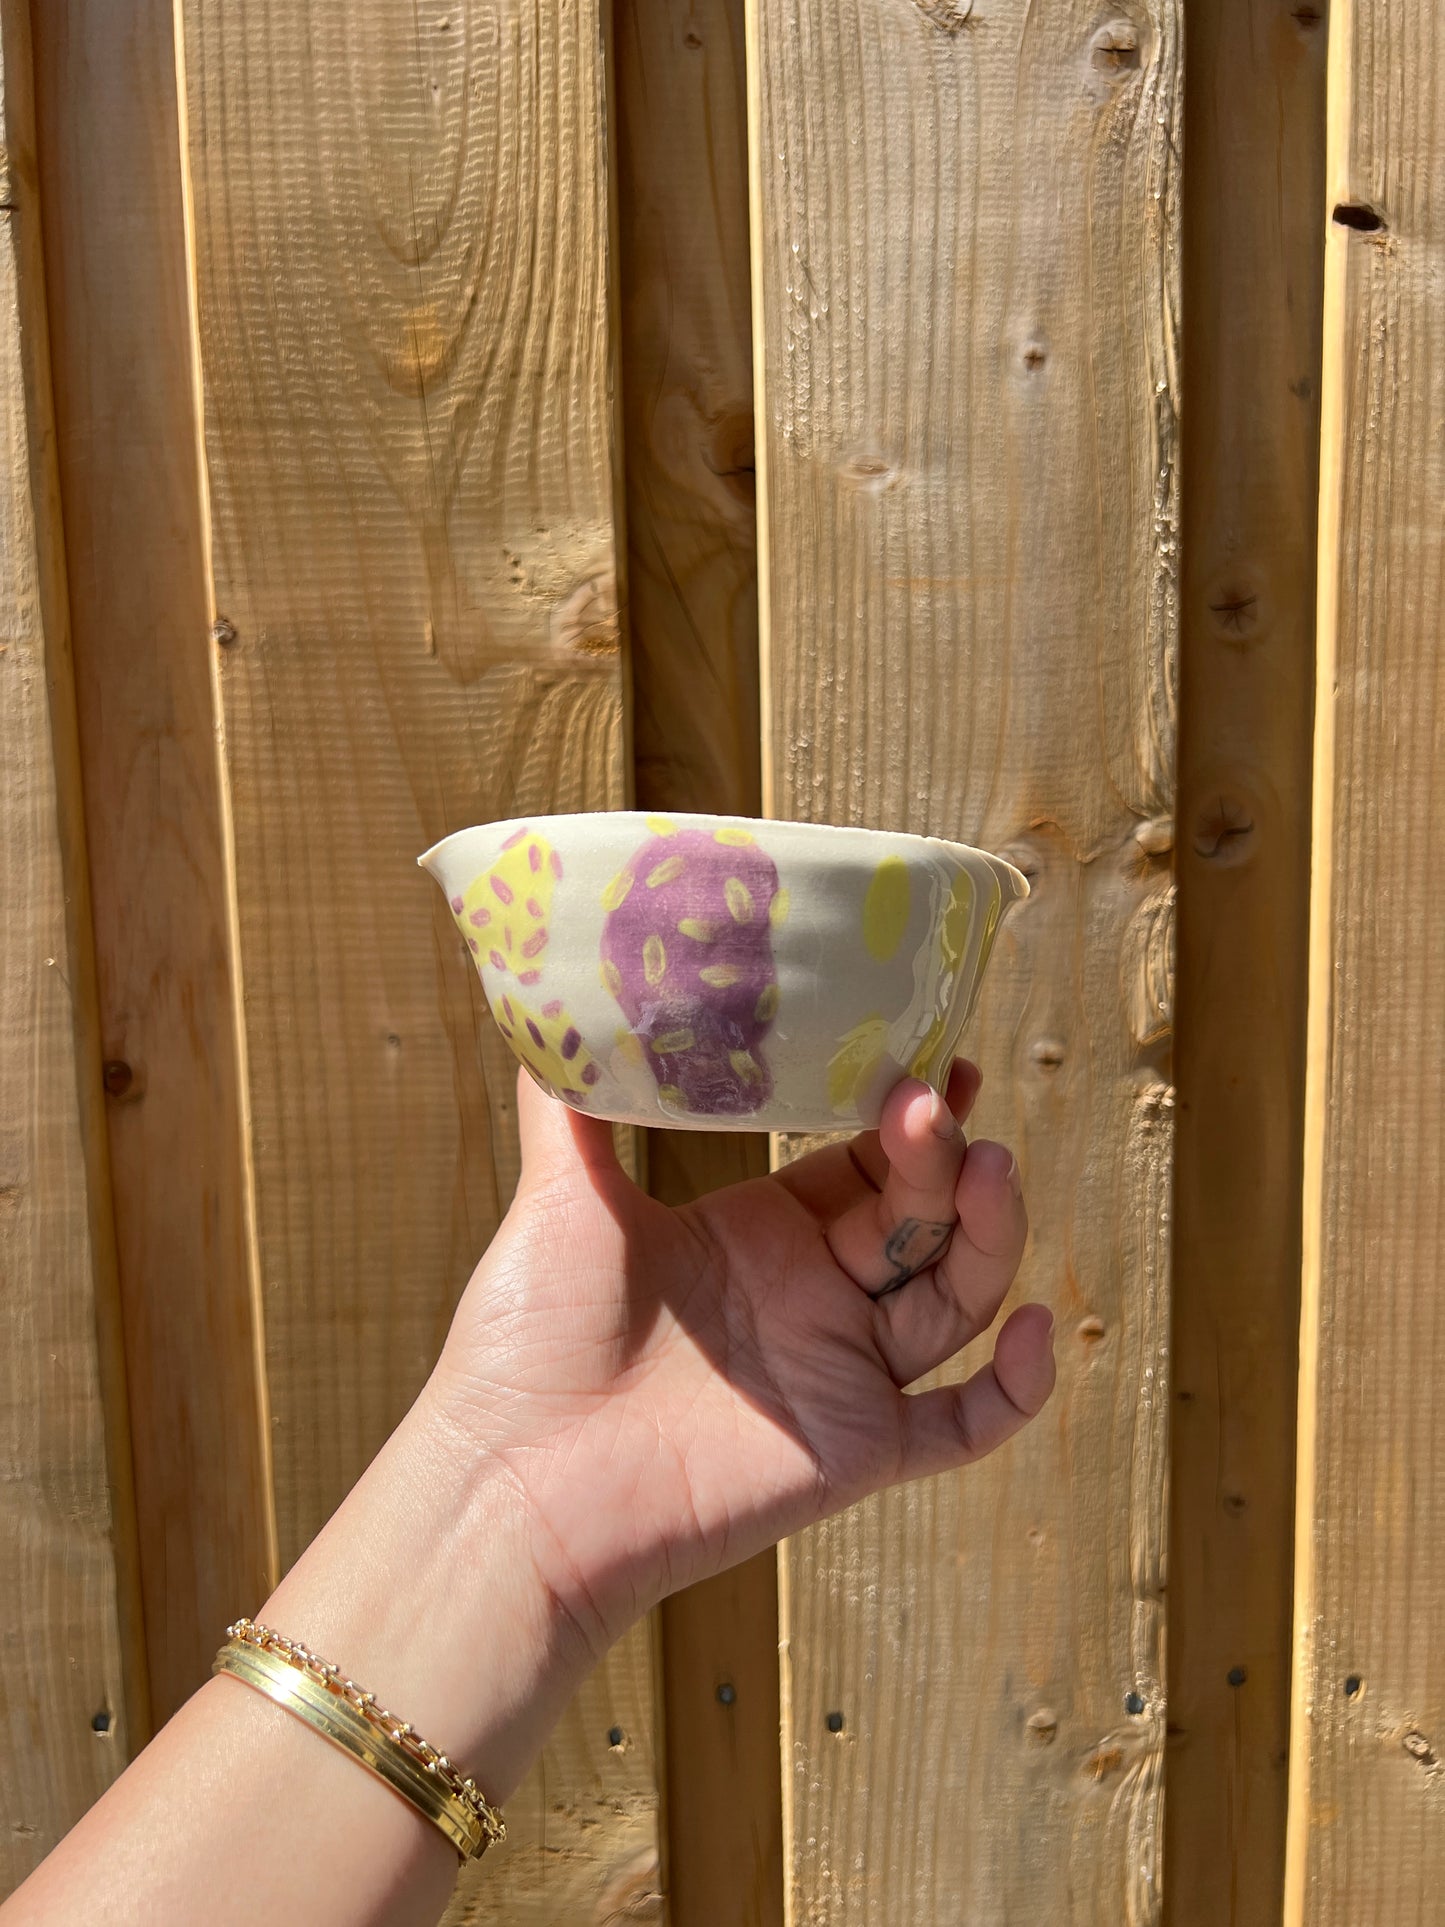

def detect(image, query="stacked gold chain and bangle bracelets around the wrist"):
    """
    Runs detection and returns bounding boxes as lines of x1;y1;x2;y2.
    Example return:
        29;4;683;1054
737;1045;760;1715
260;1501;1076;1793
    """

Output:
210;1619;507;1860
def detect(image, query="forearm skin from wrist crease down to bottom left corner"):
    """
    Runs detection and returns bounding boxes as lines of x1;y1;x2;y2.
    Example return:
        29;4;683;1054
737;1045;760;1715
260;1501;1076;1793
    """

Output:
4;1395;593;1927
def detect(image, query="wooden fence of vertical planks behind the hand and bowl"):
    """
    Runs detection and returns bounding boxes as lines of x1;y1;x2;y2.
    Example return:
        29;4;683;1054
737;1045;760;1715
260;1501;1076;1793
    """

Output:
0;0;1445;1927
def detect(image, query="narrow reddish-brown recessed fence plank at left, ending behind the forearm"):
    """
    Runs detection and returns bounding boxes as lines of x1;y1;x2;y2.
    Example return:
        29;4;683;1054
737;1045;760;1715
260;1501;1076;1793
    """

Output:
35;0;276;1721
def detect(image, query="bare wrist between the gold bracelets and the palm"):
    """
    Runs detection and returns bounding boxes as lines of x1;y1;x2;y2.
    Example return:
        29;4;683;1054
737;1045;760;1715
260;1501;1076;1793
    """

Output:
256;1393;597;1804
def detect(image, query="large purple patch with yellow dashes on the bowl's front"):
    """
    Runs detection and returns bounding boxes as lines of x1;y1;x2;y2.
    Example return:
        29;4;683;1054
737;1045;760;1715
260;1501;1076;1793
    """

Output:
601;831;778;1118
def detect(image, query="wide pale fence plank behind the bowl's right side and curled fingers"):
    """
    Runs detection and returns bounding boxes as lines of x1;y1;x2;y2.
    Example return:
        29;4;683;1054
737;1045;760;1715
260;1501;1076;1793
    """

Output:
749;0;1181;1927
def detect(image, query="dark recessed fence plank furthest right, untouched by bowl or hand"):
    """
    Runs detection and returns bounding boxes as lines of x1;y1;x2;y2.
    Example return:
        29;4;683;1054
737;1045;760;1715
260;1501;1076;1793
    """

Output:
1160;0;1327;1927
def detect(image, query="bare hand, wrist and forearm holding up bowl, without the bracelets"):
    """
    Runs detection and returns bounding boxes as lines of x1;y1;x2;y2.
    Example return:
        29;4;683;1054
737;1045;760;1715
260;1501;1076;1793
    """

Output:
2;1064;1054;1923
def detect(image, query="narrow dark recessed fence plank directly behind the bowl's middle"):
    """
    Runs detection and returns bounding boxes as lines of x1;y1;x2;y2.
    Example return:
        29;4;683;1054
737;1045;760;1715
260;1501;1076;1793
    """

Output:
615;0;782;1927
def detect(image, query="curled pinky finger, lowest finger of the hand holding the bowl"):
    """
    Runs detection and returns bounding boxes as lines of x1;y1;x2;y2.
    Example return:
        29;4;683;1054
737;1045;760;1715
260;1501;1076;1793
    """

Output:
904;1305;1054;1478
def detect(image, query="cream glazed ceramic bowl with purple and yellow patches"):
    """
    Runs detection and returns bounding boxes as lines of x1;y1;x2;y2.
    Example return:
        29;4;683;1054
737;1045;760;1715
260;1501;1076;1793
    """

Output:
420;811;1029;1131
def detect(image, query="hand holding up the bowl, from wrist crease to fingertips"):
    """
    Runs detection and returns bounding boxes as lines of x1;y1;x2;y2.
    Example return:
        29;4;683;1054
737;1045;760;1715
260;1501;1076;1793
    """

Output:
430;1064;1054;1651
